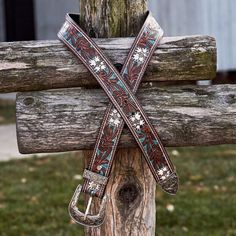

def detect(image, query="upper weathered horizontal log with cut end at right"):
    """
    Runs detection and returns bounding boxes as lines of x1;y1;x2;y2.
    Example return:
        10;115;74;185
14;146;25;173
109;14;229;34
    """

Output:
0;36;216;93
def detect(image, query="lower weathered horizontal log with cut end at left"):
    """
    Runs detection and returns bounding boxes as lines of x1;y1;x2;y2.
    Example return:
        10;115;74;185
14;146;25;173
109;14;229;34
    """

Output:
16;85;236;153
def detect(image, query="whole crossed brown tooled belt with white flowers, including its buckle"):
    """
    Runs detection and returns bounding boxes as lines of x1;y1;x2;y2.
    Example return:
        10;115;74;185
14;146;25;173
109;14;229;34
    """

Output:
58;12;178;226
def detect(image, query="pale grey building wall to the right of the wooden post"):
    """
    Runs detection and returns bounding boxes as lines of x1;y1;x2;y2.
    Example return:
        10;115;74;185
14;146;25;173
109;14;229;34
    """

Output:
149;0;236;71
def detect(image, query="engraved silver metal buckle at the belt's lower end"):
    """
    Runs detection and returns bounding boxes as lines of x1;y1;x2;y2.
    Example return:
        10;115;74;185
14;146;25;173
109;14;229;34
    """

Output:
68;185;107;227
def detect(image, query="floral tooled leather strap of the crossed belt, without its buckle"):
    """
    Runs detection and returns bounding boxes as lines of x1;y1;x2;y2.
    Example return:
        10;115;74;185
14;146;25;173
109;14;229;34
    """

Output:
58;11;178;197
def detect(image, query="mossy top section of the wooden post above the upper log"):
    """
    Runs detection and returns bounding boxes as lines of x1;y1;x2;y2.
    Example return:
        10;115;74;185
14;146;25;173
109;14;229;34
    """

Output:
80;0;147;38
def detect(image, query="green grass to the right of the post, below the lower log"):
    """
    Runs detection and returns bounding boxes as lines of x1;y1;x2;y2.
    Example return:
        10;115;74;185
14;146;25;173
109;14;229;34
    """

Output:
156;146;236;236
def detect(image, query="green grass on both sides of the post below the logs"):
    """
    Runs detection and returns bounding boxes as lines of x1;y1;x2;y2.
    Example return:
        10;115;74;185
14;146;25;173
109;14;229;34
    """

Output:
0;146;236;236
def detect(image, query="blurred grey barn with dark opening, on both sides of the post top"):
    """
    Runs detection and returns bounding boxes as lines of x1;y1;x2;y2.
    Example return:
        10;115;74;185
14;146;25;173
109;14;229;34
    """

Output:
0;0;236;74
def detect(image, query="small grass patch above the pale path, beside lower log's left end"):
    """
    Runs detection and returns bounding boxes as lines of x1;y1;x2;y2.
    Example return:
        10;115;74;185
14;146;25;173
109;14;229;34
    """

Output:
0;99;16;125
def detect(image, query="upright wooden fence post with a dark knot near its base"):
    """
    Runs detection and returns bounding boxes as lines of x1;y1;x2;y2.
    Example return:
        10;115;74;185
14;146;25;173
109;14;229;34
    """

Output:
80;0;156;236
